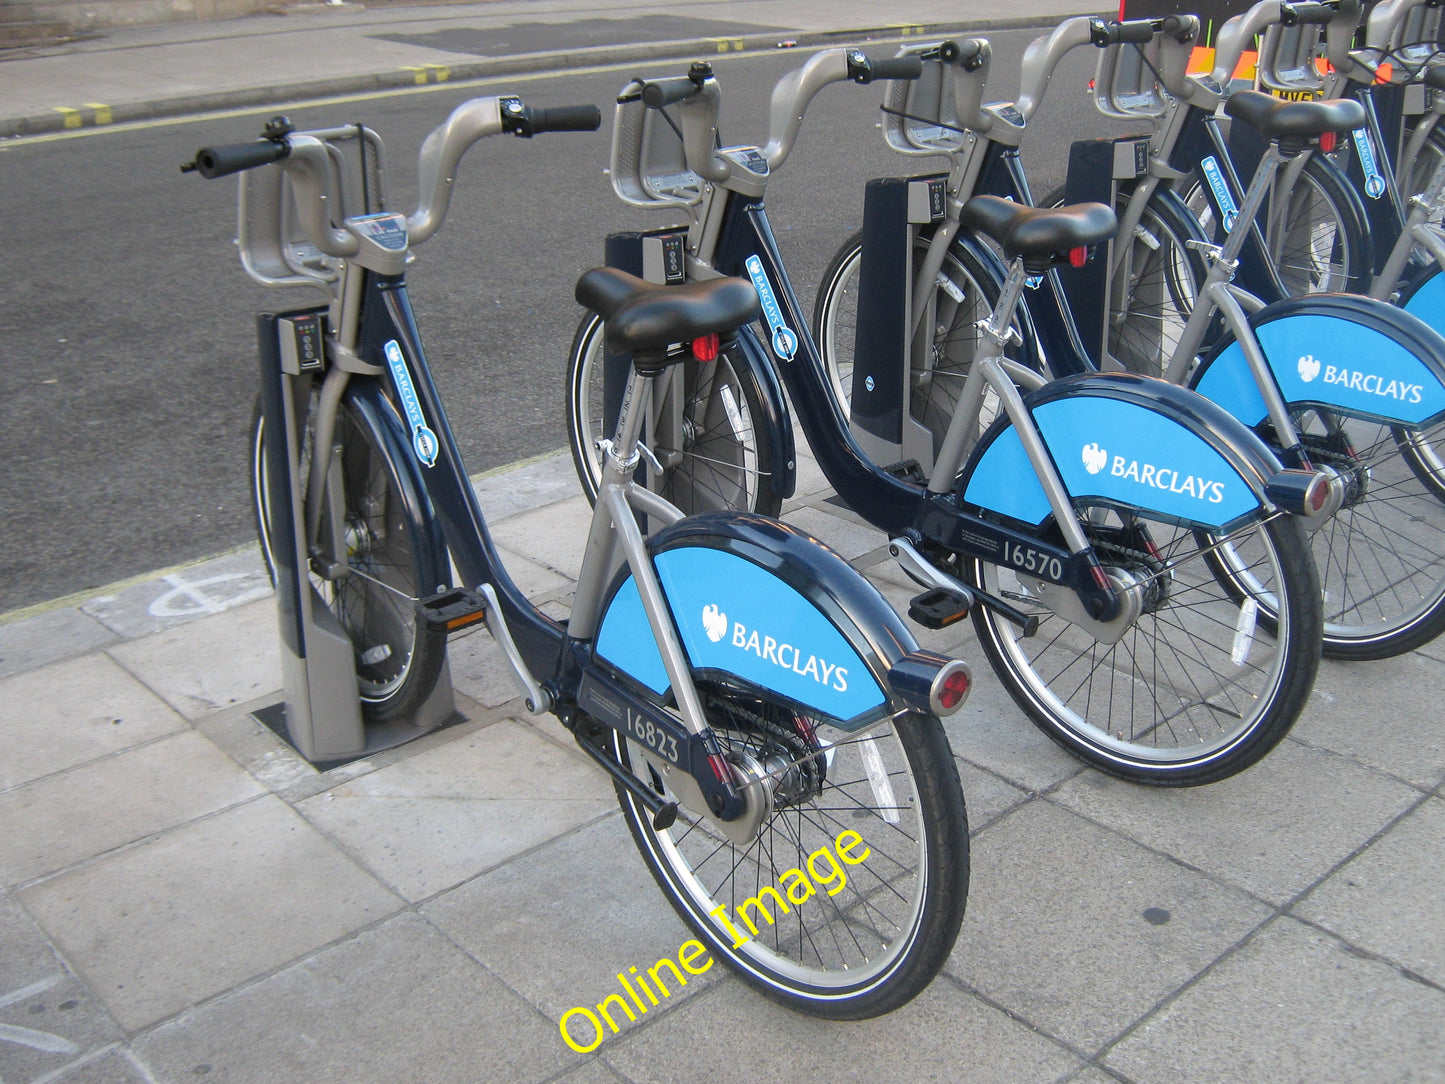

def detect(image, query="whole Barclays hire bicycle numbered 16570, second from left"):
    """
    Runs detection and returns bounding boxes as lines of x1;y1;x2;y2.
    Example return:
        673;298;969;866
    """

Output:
568;49;1325;785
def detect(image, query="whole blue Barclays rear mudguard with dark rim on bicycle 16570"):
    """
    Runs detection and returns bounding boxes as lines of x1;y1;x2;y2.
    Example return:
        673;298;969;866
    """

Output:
958;373;1280;530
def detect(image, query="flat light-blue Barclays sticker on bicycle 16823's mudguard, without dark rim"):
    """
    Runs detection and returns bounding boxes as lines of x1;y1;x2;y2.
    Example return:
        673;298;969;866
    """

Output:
597;546;886;721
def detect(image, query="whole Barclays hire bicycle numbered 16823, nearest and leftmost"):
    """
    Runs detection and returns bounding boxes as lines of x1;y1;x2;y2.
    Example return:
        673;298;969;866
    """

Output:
180;95;970;1019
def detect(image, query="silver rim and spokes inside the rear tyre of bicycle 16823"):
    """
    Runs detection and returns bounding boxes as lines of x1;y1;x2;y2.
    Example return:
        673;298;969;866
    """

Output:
629;705;928;1000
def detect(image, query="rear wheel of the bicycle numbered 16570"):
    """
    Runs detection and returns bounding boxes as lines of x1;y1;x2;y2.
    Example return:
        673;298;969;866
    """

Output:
959;509;1322;786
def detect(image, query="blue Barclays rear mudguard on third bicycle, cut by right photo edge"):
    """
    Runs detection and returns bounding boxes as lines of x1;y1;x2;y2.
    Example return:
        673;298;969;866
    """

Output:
1191;293;1445;428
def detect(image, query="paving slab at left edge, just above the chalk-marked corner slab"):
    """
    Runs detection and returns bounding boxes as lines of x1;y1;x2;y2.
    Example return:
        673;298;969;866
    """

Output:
0;731;264;885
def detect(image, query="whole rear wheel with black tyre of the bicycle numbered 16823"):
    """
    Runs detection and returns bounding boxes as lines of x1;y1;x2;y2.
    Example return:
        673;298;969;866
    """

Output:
614;685;968;1020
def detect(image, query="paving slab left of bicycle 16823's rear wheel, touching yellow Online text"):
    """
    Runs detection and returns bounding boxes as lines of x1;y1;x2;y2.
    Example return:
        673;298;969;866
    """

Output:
422;814;725;1029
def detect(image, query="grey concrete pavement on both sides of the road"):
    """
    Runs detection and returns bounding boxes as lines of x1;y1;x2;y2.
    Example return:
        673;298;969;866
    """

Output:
0;0;1445;1084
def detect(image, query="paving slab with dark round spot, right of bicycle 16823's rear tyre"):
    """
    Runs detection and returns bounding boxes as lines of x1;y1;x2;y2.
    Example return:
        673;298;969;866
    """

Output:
946;801;1272;1054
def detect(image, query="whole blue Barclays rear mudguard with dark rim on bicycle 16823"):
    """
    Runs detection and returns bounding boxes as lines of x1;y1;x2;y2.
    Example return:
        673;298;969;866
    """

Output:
595;512;918;730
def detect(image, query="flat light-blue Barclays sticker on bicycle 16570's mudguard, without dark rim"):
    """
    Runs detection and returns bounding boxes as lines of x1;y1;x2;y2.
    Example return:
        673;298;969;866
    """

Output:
964;395;1259;528
